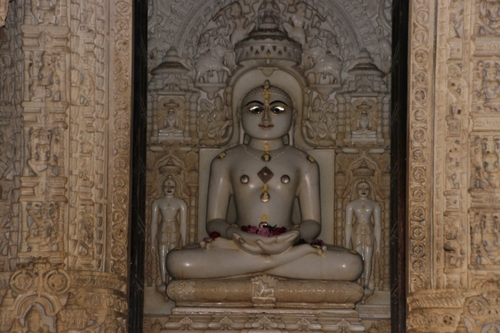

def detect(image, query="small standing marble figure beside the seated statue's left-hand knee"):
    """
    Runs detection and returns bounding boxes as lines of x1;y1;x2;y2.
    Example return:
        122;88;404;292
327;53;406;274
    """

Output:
151;176;187;292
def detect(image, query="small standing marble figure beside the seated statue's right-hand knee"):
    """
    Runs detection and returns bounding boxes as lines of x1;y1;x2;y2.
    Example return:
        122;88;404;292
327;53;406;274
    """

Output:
345;180;382;290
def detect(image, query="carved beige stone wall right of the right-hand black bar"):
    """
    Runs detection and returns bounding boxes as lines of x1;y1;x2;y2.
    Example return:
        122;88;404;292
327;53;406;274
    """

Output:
408;0;500;332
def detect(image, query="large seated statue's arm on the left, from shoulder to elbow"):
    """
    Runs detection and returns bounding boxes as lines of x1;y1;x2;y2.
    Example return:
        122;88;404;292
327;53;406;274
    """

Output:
207;157;232;238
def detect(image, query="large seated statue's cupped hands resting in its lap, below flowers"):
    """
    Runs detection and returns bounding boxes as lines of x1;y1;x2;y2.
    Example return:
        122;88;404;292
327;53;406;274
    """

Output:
232;230;300;254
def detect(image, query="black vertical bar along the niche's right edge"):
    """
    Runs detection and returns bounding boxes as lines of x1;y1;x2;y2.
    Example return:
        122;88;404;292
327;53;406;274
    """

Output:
390;0;409;333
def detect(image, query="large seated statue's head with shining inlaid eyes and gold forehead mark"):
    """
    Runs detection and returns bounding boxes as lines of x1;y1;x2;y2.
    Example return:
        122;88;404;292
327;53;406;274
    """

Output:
241;80;293;140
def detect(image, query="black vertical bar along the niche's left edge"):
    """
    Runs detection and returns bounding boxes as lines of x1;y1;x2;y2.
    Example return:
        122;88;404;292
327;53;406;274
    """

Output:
127;0;148;333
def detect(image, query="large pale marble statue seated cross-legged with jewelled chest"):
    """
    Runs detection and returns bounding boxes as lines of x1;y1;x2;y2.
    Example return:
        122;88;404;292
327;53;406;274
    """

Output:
167;81;363;281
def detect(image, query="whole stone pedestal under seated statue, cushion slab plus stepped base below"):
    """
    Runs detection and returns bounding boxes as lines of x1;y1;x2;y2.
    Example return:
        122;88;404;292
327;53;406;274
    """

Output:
161;275;366;333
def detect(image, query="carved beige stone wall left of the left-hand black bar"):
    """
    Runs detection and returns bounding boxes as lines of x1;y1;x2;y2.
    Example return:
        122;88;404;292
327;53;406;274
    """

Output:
0;0;132;332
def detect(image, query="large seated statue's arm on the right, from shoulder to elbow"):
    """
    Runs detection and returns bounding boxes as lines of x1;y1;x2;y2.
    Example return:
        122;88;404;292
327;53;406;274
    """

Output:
297;161;321;242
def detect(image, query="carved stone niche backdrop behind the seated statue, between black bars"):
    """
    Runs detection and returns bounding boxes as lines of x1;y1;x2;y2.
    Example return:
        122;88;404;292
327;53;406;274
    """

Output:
145;0;391;331
